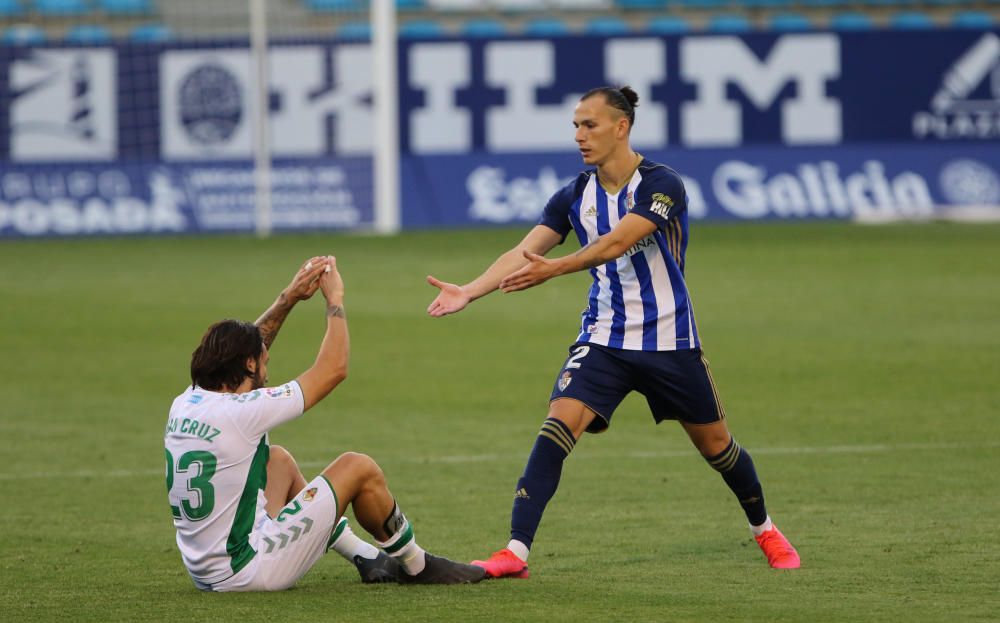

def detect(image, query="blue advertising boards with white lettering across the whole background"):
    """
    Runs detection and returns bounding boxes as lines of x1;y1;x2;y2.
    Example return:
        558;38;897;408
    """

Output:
0;29;1000;238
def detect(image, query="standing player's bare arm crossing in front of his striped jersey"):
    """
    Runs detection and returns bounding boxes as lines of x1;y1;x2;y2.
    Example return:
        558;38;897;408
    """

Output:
500;214;656;292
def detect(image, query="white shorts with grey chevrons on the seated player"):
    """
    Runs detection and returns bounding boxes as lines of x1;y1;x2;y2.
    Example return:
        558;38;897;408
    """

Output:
212;476;337;592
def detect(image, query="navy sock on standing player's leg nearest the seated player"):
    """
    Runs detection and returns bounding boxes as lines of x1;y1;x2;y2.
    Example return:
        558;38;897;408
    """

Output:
510;418;576;547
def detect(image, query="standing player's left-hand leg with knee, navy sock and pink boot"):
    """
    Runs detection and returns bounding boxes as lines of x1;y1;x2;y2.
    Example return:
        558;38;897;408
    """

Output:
472;398;597;578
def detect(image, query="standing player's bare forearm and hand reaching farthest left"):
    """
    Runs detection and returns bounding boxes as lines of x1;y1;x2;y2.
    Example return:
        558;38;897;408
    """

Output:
427;225;562;318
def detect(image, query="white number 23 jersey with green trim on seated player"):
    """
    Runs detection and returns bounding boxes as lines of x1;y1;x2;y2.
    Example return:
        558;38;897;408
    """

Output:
164;381;304;585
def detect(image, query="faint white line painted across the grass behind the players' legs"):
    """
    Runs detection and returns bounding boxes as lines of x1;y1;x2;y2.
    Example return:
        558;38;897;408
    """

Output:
0;442;1000;481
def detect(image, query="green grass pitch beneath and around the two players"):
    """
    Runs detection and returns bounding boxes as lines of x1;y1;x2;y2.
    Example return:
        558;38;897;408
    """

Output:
0;224;1000;623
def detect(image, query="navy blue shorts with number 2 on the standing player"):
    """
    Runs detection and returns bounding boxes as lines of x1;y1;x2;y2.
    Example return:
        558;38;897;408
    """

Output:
549;343;726;433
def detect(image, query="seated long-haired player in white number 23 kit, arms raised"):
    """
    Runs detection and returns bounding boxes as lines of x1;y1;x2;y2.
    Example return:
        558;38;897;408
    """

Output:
164;257;483;591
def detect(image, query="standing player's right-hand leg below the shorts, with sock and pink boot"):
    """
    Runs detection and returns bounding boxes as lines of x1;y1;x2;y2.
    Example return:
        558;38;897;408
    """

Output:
681;420;801;569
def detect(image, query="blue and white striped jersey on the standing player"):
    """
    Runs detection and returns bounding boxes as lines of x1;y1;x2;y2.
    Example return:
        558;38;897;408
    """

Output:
539;158;701;351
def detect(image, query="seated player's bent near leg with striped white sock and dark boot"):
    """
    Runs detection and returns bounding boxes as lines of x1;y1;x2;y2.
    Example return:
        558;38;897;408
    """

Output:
323;452;484;584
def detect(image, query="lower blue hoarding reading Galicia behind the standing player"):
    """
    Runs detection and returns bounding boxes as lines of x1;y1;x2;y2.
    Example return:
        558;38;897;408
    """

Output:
402;143;1000;228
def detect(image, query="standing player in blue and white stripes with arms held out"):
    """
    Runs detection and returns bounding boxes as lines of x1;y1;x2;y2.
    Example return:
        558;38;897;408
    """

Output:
427;87;799;578
